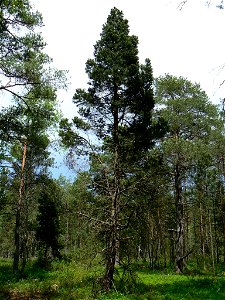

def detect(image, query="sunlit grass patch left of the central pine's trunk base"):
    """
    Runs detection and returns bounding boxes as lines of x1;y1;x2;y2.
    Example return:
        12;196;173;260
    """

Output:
0;261;103;299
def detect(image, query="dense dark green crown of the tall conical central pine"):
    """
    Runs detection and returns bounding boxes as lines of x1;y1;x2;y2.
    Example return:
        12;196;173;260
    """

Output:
61;8;158;156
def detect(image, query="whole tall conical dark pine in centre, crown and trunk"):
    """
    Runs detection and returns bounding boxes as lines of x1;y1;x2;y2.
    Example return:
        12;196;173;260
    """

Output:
61;8;161;291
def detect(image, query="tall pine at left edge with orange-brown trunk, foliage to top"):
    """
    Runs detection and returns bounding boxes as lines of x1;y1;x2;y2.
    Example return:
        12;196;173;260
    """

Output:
0;0;65;272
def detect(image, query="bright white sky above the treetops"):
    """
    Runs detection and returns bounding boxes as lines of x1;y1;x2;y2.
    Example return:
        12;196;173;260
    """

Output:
31;0;225;118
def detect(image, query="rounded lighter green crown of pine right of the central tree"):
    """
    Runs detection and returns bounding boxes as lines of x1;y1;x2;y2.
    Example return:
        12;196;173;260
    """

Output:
156;75;218;140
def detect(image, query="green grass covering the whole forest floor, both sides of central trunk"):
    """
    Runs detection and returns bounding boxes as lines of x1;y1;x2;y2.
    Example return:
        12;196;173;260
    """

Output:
0;260;225;300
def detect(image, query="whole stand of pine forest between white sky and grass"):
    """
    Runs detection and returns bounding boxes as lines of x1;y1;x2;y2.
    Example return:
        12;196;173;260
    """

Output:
0;0;225;299
